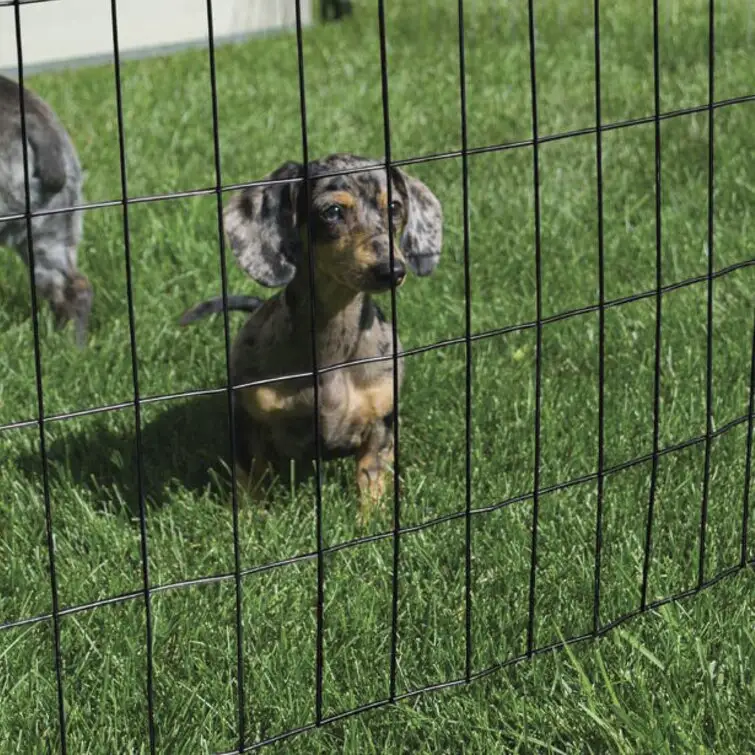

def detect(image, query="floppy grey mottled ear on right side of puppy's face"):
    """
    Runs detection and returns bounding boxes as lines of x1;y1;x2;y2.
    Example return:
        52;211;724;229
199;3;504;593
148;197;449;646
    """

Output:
393;168;443;275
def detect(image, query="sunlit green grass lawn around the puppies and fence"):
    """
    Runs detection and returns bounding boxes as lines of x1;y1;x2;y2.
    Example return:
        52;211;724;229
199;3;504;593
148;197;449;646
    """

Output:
0;0;755;753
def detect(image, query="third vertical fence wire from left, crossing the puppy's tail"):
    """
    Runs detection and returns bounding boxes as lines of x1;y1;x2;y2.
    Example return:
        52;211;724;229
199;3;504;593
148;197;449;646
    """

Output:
202;0;246;752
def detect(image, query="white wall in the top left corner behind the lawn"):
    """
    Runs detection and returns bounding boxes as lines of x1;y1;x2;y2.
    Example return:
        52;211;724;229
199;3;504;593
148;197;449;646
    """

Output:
0;0;312;73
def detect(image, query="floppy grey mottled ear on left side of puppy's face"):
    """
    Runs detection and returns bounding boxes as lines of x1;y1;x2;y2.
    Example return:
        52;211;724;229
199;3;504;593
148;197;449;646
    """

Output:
223;162;303;287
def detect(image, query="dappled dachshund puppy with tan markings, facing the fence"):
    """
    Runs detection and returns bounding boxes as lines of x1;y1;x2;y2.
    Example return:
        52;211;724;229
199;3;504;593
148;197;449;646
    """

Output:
181;154;443;518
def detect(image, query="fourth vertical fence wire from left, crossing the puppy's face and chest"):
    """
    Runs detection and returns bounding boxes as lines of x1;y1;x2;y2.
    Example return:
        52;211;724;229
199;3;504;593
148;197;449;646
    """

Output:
295;0;325;726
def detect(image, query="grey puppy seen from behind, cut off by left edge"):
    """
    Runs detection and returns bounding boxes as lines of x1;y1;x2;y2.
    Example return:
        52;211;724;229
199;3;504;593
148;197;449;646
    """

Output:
0;76;93;346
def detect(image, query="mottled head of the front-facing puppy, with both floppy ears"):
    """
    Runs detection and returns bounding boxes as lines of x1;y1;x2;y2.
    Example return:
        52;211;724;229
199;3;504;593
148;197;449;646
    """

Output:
225;155;443;292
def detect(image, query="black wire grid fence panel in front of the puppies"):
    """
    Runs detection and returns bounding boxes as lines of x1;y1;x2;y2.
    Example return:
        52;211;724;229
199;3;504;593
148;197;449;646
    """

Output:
0;0;755;755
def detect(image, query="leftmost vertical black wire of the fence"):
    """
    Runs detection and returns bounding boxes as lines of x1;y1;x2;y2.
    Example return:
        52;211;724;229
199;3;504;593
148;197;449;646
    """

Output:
13;0;68;755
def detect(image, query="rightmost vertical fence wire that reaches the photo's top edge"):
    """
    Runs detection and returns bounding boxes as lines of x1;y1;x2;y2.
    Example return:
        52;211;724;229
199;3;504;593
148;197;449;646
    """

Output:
697;0;716;590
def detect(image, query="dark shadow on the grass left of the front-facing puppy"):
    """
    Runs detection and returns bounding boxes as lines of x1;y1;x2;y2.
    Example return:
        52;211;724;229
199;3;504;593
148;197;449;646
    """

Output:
17;394;230;516
